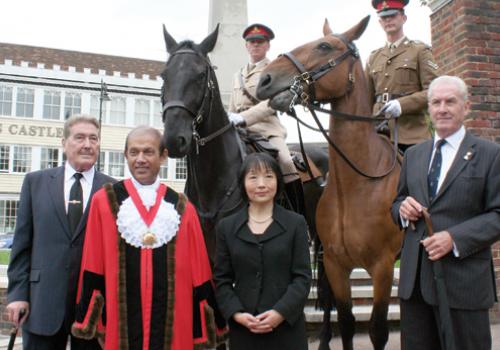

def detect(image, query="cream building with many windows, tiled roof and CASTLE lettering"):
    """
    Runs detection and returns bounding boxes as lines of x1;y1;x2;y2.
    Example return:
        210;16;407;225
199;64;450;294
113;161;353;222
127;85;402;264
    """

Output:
0;43;187;233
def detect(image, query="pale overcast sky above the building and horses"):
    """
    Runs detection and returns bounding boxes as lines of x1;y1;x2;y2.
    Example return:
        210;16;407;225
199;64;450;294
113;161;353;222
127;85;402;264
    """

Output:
0;0;431;142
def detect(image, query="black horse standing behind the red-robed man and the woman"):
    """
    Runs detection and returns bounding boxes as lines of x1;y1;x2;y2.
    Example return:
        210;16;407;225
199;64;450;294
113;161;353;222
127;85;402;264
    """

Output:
161;26;328;270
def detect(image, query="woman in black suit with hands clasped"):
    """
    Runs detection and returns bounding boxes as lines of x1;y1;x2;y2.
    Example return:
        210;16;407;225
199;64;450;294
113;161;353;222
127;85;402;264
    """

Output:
214;153;311;350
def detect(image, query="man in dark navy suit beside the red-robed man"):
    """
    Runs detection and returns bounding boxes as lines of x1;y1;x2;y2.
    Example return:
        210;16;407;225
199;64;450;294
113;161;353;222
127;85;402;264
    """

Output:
7;115;114;350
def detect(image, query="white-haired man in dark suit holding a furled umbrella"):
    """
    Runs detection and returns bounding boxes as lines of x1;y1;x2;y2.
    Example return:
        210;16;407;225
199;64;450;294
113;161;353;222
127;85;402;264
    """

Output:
392;76;500;350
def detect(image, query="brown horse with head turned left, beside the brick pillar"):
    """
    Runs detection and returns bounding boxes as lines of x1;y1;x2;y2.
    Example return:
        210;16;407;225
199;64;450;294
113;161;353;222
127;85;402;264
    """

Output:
257;17;402;349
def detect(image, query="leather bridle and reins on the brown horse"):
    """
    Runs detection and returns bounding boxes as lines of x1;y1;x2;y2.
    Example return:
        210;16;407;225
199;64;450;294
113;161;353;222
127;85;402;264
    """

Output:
283;34;398;179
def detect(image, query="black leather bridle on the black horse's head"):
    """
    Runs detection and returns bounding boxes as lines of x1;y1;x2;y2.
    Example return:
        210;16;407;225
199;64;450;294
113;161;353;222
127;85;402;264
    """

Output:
162;49;233;153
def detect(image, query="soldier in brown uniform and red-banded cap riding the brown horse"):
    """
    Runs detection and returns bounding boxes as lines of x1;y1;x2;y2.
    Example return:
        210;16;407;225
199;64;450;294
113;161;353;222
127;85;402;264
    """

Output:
365;0;438;152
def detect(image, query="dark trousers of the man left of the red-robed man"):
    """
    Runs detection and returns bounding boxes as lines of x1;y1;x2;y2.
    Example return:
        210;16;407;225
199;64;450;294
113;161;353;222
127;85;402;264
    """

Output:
23;326;101;350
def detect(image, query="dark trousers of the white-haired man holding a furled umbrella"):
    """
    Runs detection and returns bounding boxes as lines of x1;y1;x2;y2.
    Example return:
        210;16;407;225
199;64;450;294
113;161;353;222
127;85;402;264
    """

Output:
400;254;491;350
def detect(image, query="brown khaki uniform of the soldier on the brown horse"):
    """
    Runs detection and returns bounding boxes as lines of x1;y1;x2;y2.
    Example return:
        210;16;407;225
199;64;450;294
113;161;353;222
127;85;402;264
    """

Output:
365;38;438;145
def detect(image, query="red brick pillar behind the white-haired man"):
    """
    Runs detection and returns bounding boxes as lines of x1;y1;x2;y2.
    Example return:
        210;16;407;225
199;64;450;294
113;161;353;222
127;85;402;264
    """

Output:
427;0;500;322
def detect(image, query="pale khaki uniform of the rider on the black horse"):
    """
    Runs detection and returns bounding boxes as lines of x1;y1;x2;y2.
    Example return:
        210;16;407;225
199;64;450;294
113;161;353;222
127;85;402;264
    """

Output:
229;58;298;178
